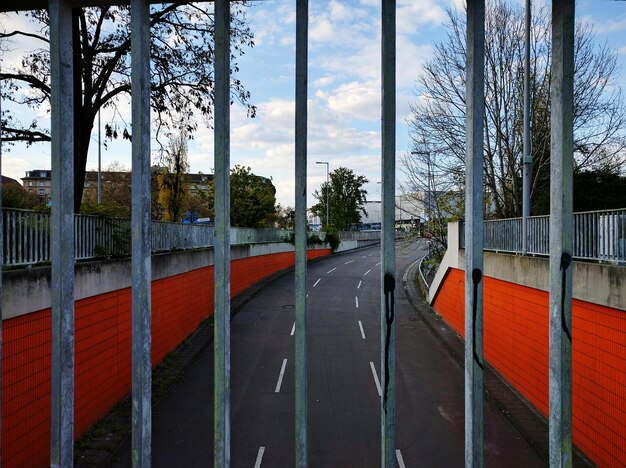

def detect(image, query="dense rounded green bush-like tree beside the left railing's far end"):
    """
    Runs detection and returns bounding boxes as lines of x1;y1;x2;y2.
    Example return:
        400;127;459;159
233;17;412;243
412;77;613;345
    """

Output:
202;165;276;228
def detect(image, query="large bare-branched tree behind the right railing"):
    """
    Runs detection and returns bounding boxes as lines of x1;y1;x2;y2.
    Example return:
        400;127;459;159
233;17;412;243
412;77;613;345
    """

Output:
402;0;626;217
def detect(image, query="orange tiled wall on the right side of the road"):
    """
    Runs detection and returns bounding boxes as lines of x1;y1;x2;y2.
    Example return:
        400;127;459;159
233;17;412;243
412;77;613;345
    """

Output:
434;269;626;466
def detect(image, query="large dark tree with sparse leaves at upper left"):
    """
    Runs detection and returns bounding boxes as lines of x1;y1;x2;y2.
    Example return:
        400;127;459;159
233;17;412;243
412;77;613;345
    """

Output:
0;2;256;212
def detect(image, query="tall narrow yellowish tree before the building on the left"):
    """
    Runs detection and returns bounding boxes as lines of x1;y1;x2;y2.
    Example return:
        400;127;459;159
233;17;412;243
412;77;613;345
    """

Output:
158;133;189;222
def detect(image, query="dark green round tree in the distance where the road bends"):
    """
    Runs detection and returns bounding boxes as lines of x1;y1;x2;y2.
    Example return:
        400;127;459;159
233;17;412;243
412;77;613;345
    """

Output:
311;167;369;231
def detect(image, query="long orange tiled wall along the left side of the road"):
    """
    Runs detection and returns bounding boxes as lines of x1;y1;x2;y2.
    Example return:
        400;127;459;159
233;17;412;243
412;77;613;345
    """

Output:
2;250;331;467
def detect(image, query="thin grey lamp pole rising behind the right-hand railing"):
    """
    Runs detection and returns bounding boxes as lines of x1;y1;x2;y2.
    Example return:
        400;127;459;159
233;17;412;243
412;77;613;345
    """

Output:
522;0;533;255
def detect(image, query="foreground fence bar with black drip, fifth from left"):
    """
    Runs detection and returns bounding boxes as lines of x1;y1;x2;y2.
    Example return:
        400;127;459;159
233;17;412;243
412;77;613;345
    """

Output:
380;0;396;468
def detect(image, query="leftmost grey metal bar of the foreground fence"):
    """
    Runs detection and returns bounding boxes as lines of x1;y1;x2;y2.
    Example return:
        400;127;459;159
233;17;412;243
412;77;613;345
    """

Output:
48;0;74;467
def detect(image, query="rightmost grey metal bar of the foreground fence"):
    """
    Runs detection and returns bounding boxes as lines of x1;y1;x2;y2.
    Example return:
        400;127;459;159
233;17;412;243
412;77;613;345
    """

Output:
549;0;574;467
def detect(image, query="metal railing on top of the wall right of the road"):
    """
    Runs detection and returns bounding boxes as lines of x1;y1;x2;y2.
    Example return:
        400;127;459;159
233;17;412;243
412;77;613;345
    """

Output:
459;208;626;264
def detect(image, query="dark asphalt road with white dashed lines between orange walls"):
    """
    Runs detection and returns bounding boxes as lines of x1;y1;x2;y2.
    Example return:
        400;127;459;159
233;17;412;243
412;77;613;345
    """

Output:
114;242;545;468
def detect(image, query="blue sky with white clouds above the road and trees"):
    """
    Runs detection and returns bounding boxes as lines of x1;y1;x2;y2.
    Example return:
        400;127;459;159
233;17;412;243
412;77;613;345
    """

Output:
0;0;626;205
